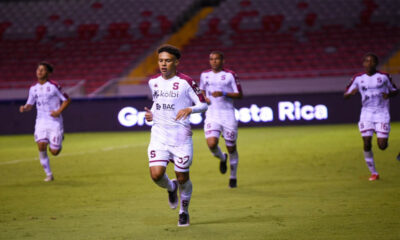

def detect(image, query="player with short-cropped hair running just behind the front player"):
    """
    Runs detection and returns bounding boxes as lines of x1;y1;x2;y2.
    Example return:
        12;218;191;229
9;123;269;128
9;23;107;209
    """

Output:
200;51;242;188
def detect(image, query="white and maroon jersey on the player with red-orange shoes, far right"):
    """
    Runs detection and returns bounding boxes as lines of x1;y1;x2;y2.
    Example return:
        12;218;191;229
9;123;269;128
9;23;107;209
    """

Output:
346;72;397;122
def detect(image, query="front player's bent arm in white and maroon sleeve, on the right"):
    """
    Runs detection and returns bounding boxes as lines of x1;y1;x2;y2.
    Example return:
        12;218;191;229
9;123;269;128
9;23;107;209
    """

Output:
175;83;208;120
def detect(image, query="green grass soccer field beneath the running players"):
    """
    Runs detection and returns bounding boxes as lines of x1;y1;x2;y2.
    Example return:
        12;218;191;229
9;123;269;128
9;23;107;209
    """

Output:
0;123;400;240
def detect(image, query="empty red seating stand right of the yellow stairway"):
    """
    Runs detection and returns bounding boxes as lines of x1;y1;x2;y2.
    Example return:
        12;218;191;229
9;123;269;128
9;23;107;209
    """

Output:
180;0;400;80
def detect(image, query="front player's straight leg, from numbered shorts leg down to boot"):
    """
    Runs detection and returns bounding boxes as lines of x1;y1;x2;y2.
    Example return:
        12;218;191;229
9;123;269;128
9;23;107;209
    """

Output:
171;144;193;227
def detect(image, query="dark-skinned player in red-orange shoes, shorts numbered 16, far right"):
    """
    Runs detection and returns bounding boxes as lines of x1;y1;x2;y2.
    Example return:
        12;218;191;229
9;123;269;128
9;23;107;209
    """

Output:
344;53;398;181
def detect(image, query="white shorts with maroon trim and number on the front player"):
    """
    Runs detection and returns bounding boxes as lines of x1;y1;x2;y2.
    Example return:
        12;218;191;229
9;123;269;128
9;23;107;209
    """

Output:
147;141;193;172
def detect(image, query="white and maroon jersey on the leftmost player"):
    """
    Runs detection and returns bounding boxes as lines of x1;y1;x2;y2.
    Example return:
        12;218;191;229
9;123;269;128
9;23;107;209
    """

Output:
26;81;68;125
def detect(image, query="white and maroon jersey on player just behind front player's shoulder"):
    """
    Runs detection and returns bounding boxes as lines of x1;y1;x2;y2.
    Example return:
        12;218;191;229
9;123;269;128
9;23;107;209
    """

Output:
200;69;242;119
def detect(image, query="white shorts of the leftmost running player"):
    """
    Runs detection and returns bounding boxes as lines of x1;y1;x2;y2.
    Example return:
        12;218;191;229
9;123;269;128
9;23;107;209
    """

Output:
34;125;64;150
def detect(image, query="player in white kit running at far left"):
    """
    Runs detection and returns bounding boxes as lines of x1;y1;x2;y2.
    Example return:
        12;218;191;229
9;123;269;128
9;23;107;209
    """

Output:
19;62;71;182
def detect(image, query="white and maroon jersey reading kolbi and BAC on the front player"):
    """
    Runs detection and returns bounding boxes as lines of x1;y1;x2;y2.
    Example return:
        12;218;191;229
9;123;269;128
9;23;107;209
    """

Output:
149;73;207;146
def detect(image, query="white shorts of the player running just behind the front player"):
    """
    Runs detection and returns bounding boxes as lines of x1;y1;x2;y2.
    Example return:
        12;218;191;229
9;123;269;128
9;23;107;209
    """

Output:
204;120;238;147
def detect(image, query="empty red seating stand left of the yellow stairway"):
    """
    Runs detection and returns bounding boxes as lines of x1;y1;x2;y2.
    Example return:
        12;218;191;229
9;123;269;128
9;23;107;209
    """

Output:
0;0;198;94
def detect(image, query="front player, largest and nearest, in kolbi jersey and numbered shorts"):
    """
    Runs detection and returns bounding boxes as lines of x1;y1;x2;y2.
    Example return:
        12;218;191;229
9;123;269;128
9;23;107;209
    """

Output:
145;45;207;227
